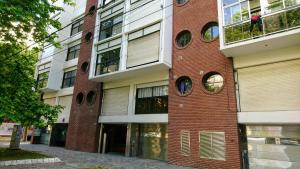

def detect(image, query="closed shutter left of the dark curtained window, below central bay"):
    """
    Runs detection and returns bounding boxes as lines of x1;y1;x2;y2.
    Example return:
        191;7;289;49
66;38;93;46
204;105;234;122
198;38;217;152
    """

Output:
102;86;129;116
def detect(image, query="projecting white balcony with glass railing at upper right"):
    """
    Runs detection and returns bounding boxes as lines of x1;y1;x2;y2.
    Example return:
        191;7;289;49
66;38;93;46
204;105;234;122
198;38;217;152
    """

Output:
220;0;300;57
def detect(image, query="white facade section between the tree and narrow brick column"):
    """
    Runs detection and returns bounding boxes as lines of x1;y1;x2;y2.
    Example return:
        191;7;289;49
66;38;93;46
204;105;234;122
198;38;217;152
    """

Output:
36;0;86;146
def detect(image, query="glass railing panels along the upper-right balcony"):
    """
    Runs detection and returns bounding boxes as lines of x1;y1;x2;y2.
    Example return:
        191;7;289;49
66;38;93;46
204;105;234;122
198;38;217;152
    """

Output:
223;6;300;45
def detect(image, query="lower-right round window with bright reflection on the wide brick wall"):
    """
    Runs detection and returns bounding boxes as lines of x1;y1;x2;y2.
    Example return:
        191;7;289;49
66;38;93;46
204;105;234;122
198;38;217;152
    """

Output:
202;72;224;93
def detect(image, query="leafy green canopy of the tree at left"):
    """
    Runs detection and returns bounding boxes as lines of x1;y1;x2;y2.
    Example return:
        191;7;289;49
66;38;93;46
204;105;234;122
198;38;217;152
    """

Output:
0;0;73;148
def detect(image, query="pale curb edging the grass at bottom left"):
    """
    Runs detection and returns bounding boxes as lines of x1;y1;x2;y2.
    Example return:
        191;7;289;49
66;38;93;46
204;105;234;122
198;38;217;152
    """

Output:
0;157;62;166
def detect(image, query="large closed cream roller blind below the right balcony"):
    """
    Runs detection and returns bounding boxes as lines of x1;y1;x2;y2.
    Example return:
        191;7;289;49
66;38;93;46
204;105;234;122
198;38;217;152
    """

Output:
238;60;300;111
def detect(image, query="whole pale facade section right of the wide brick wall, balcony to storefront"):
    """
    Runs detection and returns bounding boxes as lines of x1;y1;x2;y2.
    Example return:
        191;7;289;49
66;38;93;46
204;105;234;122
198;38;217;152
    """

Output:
218;0;300;169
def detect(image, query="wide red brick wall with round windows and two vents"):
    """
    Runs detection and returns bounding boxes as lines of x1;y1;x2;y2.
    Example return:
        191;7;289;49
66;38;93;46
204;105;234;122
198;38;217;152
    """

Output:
168;0;241;169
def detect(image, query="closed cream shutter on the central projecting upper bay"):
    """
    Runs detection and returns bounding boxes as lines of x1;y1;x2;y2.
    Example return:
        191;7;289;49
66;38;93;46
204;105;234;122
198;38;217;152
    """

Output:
127;31;160;68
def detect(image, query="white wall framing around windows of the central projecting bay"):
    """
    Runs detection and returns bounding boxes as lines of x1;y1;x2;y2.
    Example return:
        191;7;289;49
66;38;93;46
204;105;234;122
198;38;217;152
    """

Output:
89;0;173;79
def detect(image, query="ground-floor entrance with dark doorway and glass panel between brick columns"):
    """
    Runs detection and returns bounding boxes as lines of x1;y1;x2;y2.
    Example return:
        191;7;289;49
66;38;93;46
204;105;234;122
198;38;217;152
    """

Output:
99;123;168;161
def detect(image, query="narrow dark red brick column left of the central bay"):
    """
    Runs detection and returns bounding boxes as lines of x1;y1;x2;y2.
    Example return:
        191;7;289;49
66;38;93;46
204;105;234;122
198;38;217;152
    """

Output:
66;0;102;152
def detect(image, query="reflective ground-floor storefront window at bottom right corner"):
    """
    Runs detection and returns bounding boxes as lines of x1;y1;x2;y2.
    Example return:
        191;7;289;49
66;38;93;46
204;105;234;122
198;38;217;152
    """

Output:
241;124;300;169
